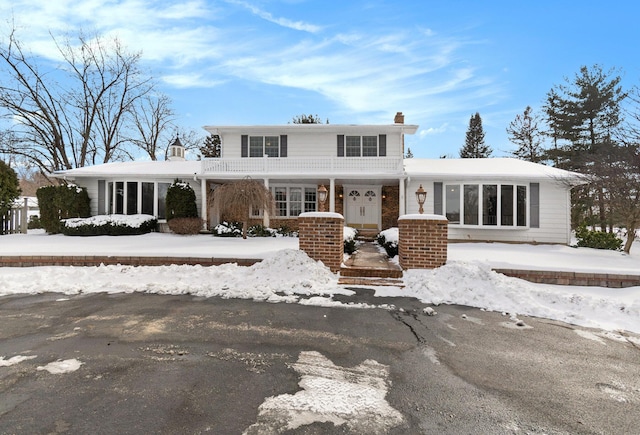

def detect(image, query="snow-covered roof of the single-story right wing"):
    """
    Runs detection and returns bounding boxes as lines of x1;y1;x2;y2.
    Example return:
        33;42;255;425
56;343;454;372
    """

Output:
404;158;582;184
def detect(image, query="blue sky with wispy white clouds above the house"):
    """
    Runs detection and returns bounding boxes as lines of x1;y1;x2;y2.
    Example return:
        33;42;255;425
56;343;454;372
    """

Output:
0;0;640;158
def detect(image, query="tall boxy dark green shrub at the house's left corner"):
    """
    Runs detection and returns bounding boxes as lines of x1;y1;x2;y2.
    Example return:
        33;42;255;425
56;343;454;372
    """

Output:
36;184;91;234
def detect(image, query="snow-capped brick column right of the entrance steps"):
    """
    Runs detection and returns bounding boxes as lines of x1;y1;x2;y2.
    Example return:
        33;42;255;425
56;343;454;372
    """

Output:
398;214;449;270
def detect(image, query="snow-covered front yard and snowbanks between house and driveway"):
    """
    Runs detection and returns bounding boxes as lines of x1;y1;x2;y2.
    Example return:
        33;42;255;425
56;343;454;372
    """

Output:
0;231;640;333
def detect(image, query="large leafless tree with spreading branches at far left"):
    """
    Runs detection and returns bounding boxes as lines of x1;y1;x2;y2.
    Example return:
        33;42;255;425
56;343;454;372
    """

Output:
0;30;159;172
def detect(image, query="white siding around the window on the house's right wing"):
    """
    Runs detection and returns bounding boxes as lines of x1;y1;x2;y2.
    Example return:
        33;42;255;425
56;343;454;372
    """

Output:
406;179;571;244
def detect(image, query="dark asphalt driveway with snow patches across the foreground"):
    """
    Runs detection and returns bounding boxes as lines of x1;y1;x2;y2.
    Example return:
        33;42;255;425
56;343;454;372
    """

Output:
0;292;640;434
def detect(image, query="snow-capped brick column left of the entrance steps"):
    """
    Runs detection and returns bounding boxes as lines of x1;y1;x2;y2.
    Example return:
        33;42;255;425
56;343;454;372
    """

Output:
298;212;344;273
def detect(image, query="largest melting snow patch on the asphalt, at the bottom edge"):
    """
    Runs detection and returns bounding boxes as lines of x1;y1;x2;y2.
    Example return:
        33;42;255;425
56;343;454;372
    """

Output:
244;351;403;435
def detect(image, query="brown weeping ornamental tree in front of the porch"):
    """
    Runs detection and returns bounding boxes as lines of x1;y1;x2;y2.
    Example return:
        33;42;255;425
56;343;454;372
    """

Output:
213;177;274;239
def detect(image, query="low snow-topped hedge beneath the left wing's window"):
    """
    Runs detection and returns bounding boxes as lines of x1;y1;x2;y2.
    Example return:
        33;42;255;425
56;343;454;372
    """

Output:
62;214;158;236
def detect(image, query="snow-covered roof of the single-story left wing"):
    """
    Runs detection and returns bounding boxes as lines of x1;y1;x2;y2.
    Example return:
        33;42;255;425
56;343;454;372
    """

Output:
54;160;202;178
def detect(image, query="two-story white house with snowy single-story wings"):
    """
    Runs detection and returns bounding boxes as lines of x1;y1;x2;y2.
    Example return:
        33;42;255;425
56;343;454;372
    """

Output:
56;113;579;244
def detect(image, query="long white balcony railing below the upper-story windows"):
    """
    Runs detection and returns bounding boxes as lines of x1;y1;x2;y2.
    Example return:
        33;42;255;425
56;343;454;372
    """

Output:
202;157;403;175
